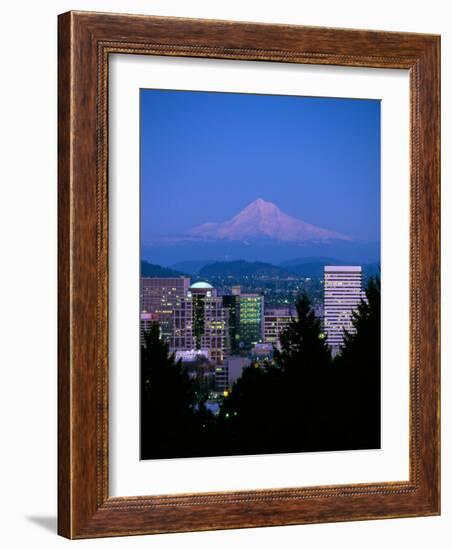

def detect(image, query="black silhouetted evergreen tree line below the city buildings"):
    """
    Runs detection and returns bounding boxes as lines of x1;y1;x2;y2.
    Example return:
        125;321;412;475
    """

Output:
141;278;380;458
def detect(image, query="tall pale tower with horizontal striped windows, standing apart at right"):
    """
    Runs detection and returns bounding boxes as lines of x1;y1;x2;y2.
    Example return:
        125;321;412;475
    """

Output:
324;265;365;354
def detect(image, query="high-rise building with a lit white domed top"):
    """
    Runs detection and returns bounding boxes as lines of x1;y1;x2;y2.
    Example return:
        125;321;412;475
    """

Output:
171;282;230;364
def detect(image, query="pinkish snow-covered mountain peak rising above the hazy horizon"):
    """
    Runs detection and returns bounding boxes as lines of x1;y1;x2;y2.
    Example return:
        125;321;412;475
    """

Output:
189;198;351;242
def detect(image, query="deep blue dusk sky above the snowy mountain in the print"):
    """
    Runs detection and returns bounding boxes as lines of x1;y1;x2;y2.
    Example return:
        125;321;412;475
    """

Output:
140;89;380;242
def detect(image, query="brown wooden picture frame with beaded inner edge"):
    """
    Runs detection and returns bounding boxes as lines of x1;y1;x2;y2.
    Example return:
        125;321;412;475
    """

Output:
58;12;440;538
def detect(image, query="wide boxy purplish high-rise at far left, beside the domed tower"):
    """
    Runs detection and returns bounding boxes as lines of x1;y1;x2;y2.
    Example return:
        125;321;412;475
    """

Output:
141;277;190;341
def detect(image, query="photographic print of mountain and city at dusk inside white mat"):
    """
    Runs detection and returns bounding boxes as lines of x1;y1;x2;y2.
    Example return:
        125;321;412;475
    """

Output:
137;89;384;460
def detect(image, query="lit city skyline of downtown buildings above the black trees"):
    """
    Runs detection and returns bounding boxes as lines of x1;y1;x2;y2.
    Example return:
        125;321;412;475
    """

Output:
140;265;366;398
